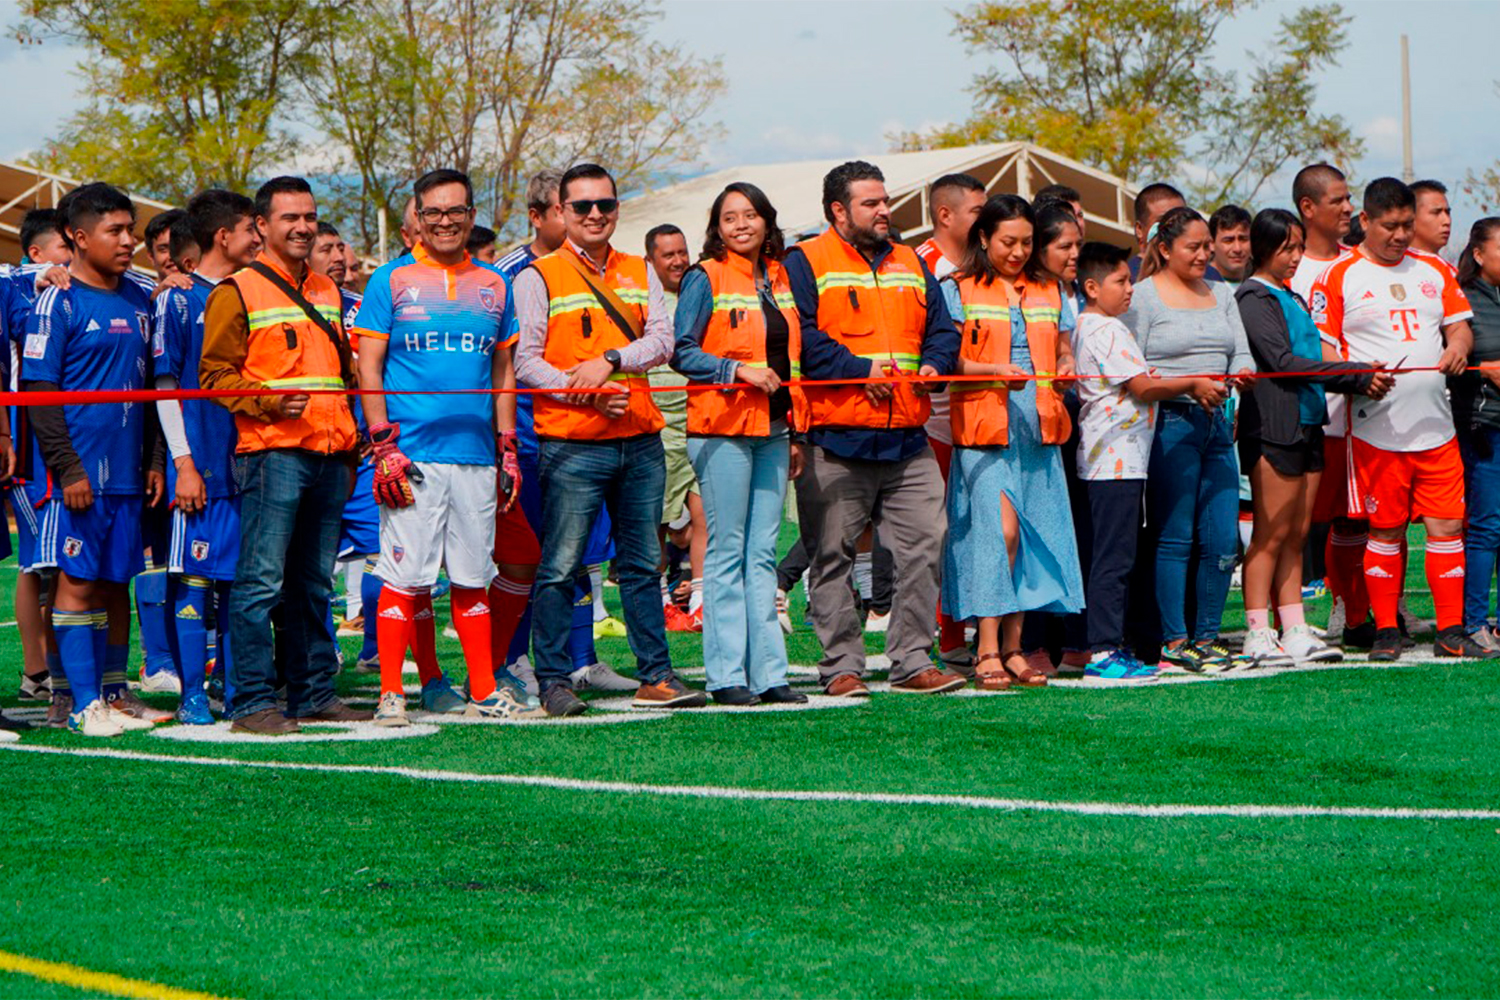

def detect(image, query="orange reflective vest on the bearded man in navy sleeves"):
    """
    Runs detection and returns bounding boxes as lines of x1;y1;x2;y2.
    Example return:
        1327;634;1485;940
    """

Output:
797;228;932;429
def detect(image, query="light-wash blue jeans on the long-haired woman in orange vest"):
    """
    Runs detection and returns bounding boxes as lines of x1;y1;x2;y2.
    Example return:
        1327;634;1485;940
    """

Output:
687;421;791;694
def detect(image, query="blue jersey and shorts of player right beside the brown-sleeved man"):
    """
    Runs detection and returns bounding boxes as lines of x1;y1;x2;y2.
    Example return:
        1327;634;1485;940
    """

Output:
152;274;239;496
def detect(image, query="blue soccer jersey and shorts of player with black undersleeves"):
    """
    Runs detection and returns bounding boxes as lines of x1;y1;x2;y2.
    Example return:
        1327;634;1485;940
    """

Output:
21;279;152;496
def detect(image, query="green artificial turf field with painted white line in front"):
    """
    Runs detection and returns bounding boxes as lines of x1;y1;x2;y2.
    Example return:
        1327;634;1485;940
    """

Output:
0;527;1500;997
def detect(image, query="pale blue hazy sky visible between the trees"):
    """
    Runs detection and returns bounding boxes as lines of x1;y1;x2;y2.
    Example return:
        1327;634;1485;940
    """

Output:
0;0;1500;240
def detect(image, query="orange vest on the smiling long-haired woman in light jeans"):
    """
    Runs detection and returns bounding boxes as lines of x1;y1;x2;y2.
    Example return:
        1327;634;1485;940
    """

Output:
687;253;807;438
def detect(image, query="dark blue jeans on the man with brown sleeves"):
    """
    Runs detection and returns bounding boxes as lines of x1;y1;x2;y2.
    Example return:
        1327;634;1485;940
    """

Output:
230;448;353;718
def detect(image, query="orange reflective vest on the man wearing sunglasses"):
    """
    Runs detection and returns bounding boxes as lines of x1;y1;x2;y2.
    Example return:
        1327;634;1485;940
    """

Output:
531;244;666;441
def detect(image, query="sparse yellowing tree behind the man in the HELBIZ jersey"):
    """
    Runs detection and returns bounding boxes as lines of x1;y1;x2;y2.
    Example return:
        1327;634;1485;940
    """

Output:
300;0;725;254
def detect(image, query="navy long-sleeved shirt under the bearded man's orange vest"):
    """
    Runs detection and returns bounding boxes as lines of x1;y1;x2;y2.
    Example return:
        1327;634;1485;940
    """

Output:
782;235;959;462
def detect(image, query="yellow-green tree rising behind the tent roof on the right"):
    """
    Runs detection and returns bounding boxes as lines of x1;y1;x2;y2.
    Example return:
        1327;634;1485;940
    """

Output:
896;0;1362;205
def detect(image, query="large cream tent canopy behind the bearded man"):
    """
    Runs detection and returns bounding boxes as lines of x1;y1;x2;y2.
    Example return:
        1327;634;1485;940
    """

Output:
614;142;1136;253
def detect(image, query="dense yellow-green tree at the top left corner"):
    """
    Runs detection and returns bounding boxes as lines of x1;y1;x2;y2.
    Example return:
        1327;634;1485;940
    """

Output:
15;0;345;201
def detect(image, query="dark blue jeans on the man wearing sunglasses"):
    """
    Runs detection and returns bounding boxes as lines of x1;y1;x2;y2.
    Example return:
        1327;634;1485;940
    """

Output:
531;435;672;691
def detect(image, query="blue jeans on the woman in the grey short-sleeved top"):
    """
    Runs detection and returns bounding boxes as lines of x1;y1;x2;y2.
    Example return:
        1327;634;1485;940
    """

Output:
1148;403;1239;643
